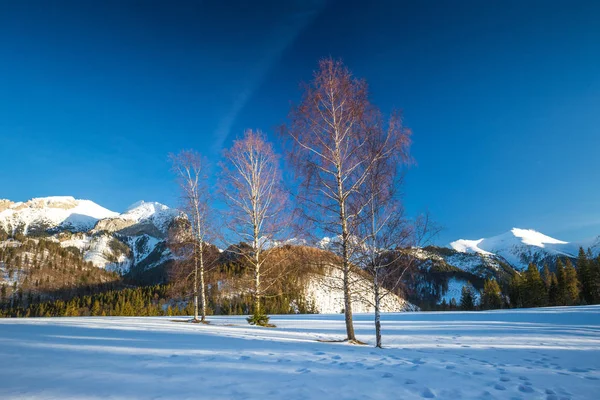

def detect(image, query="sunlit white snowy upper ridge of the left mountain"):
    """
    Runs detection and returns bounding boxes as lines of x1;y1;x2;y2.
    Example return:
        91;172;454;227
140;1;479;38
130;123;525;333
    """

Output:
0;196;118;234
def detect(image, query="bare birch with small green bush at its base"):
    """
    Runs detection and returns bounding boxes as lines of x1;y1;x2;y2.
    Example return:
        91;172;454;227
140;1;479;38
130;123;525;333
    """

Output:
221;130;287;325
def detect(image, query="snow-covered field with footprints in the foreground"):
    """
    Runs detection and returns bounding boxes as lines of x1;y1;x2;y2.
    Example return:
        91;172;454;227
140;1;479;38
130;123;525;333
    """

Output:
0;306;600;400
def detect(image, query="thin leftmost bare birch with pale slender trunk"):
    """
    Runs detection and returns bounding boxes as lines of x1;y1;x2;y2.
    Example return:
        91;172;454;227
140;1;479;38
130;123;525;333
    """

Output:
169;150;212;322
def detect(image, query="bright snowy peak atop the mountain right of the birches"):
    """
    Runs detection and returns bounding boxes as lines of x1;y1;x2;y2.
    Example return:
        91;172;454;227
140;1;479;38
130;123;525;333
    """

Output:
450;228;600;270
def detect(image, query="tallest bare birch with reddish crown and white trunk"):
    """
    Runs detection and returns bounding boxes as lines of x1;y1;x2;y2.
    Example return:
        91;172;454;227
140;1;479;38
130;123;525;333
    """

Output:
286;58;404;342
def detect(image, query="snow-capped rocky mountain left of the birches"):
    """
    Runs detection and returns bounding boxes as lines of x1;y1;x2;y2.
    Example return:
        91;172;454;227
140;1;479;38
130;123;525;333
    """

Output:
0;196;181;275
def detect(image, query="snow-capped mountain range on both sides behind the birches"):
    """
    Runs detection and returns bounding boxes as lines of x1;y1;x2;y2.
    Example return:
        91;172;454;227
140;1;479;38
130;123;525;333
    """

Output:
0;196;600;303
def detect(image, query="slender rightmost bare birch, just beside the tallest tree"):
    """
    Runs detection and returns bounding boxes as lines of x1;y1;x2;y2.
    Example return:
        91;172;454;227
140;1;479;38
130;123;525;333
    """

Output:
355;113;415;347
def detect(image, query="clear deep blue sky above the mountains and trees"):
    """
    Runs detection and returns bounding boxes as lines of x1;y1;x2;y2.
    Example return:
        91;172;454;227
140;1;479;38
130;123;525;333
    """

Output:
0;0;600;243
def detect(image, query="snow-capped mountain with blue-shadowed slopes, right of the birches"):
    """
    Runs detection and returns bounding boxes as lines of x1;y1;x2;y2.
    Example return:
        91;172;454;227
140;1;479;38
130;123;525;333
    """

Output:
406;228;600;304
